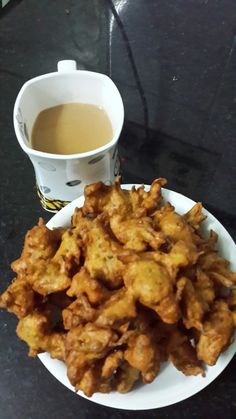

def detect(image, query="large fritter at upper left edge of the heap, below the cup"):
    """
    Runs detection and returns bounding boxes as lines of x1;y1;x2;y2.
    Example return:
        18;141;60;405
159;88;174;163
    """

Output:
9;220;80;295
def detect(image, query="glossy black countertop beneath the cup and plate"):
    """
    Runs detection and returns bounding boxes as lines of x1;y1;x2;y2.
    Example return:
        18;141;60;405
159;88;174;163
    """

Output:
0;0;236;419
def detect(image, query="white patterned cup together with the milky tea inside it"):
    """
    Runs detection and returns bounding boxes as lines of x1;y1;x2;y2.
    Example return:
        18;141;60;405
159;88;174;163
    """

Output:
13;60;124;212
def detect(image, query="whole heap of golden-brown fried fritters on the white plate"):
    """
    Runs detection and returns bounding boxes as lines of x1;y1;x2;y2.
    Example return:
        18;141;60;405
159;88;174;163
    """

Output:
0;178;236;397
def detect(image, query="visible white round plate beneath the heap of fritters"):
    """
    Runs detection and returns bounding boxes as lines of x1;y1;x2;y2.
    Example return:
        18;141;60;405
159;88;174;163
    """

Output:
39;185;236;410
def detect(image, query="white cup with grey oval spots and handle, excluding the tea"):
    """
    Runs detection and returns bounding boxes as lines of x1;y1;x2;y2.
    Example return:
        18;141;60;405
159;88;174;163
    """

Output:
13;60;124;212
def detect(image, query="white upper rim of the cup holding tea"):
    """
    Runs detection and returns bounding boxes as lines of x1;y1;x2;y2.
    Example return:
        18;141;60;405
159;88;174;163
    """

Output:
13;70;124;160
